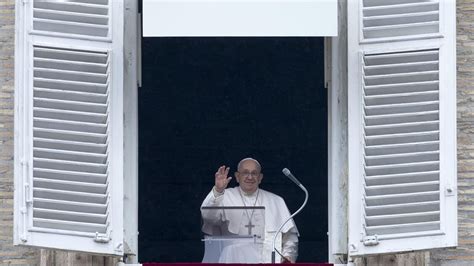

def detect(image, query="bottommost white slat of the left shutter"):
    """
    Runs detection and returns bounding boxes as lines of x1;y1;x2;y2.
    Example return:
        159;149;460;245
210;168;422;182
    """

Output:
33;218;107;233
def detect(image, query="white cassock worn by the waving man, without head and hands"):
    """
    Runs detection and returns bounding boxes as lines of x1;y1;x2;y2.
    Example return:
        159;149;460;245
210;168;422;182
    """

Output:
201;187;298;263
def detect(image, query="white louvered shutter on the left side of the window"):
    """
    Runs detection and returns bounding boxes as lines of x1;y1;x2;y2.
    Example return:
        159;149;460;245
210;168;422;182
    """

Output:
14;0;123;255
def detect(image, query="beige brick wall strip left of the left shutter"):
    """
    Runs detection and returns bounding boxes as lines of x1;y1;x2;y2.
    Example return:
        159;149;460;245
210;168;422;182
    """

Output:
0;0;39;265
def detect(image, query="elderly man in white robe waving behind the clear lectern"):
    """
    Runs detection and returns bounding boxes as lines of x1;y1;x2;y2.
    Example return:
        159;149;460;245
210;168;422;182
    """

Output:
201;158;298;263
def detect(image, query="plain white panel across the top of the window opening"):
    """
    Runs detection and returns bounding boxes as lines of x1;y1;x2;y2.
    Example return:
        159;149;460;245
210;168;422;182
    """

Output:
143;0;337;37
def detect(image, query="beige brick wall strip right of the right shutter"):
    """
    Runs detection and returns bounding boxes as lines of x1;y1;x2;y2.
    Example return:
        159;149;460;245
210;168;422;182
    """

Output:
431;0;474;266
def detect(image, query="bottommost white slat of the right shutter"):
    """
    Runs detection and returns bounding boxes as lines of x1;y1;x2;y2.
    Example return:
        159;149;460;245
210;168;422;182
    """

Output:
366;221;440;235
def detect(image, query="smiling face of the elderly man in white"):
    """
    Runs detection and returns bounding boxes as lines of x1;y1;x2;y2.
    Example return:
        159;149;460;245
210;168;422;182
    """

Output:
235;160;263;193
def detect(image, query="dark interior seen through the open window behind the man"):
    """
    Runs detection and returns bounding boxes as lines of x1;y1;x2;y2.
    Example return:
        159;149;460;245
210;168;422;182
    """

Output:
139;38;328;262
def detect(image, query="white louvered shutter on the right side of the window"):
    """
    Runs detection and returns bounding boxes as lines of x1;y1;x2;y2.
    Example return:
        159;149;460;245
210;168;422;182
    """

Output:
348;0;457;256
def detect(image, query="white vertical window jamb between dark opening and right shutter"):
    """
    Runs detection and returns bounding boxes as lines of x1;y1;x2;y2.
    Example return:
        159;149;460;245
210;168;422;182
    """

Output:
328;0;348;263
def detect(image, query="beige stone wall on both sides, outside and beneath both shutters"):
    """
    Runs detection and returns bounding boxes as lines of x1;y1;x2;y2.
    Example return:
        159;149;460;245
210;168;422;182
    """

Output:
0;0;474;266
